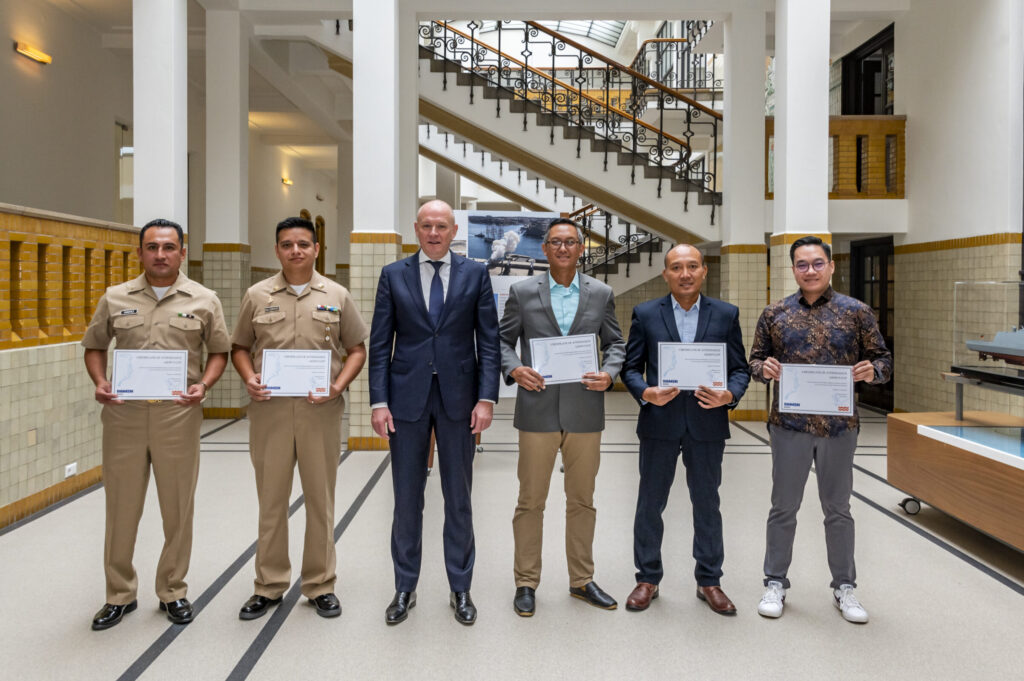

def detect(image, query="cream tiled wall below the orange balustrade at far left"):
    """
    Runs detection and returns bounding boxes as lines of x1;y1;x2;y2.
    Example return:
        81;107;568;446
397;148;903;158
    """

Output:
0;343;102;507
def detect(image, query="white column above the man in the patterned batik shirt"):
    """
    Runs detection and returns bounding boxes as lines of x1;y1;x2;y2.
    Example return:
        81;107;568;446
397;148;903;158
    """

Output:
774;0;831;233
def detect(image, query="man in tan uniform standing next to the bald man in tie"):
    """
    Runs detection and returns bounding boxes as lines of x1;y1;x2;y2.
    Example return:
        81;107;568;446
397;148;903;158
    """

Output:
231;217;369;620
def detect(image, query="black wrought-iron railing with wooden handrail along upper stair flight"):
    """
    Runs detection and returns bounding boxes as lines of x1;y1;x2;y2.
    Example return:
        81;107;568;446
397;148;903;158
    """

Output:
420;20;722;224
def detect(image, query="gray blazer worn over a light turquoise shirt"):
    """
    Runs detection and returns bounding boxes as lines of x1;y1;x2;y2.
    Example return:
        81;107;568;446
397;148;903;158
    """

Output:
499;272;626;433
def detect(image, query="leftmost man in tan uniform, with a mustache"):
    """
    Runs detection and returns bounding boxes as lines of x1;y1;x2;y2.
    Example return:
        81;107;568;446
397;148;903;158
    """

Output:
82;220;230;630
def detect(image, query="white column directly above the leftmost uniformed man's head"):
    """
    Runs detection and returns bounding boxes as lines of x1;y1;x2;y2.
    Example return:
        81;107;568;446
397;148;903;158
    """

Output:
132;0;188;230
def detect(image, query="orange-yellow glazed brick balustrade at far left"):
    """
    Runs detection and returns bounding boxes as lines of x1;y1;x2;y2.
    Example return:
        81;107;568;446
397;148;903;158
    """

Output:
0;204;140;349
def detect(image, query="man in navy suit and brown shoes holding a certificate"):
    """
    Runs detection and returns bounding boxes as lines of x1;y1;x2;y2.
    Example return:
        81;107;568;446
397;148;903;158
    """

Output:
622;244;751;614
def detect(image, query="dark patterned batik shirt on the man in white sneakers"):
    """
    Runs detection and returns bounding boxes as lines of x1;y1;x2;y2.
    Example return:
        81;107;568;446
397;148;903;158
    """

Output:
751;287;893;437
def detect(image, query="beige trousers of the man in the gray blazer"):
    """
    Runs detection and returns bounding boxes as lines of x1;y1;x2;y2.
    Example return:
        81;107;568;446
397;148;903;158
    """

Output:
512;430;601;589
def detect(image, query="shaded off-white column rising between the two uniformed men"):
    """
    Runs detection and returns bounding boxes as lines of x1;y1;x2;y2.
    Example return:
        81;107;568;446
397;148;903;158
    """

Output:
206;10;249;244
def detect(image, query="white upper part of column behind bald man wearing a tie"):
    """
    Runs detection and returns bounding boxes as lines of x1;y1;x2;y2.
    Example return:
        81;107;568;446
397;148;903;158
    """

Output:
352;0;419;233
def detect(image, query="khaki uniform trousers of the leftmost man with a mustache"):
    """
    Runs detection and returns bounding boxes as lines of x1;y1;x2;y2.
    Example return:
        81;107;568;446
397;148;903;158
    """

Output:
101;401;203;605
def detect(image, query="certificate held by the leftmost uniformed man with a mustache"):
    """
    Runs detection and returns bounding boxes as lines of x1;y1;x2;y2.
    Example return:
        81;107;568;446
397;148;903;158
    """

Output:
111;350;188;399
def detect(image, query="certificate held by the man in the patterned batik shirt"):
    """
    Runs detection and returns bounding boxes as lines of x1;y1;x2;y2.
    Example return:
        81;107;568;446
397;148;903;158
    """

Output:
778;365;853;416
